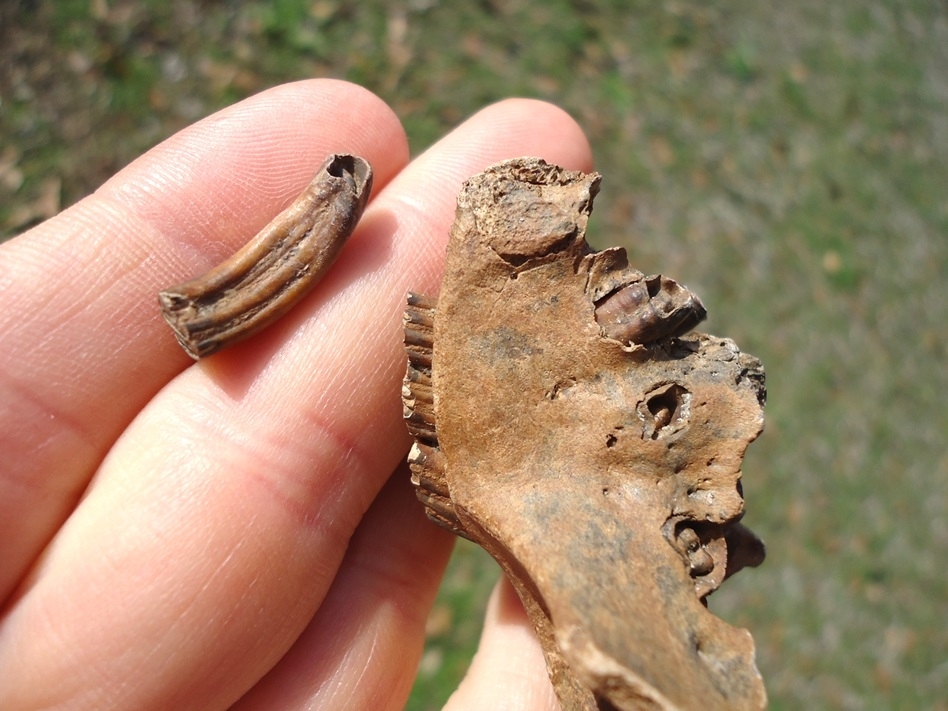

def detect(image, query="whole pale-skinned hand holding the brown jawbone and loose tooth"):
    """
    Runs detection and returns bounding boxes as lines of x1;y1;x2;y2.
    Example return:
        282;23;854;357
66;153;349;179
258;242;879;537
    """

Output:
0;80;591;711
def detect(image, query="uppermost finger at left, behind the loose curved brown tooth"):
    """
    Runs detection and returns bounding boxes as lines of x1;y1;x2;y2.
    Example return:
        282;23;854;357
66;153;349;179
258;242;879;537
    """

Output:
0;81;407;600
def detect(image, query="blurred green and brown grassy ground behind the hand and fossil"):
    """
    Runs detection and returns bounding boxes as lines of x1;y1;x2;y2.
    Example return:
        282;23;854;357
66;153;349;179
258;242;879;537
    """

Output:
0;0;948;711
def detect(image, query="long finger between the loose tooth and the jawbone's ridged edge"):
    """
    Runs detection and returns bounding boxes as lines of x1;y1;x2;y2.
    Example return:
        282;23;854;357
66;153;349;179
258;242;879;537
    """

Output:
0;101;589;708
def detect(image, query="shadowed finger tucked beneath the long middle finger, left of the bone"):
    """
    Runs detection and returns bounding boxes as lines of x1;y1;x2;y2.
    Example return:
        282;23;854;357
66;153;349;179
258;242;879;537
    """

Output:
228;466;454;711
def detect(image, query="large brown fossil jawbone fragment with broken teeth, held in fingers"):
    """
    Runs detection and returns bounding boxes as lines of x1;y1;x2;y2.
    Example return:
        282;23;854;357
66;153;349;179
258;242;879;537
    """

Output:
403;158;766;711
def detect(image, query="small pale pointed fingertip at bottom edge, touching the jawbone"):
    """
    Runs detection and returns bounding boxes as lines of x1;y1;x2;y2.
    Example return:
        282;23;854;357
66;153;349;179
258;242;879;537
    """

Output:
444;578;560;711
